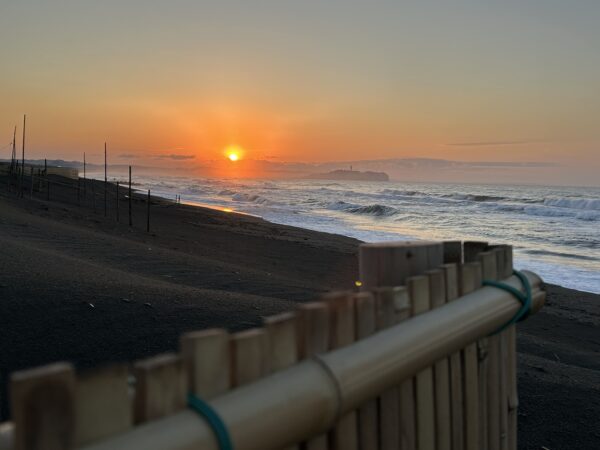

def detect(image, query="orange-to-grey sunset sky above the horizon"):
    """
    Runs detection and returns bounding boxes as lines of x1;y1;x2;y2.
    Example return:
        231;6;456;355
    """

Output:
0;0;600;185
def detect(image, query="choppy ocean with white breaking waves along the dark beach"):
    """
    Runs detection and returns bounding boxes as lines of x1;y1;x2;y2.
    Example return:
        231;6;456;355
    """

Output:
118;176;600;293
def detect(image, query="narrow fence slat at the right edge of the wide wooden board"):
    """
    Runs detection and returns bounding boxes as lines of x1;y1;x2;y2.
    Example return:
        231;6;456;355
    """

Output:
426;269;452;450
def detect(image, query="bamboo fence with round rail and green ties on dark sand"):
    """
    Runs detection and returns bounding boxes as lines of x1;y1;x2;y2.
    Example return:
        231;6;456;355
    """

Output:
0;241;545;450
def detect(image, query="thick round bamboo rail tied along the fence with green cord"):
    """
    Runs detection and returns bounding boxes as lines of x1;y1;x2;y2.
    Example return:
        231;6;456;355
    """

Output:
79;272;545;450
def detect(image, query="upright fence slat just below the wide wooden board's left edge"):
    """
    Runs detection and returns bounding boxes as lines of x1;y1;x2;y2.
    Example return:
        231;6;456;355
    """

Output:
354;292;380;450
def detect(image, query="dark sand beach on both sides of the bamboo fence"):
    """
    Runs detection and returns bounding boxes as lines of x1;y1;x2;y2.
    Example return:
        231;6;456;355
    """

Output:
0;178;600;449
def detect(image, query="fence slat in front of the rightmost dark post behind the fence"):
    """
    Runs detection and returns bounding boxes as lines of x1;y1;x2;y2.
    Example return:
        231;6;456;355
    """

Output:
460;263;481;450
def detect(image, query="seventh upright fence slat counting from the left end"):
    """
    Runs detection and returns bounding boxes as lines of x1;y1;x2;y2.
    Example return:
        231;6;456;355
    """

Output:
297;302;329;450
